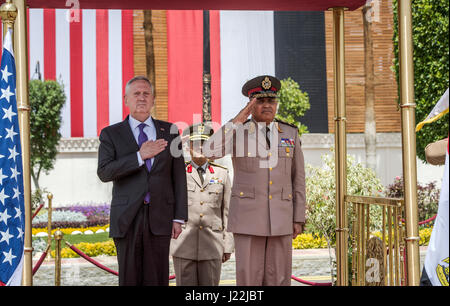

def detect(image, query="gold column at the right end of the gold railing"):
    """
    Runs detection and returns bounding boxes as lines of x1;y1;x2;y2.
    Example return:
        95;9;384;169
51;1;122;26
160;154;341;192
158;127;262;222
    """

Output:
398;0;420;286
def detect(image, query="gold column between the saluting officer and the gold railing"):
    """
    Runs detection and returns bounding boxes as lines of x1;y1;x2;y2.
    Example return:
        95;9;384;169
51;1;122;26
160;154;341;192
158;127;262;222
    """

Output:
332;7;348;286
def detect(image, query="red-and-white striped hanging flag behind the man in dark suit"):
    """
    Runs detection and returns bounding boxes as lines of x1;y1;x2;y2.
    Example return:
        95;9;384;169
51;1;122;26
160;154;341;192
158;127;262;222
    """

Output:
23;9;134;137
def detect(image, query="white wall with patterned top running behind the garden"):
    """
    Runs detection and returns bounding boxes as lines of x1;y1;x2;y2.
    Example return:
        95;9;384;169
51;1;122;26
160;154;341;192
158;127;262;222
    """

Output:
40;133;444;206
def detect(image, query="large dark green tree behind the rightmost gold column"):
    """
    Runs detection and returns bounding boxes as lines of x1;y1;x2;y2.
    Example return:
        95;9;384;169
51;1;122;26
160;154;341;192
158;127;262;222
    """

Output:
394;0;449;161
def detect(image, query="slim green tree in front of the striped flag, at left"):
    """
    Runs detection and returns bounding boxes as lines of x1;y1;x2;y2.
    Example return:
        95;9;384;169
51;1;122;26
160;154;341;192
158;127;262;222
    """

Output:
29;80;66;194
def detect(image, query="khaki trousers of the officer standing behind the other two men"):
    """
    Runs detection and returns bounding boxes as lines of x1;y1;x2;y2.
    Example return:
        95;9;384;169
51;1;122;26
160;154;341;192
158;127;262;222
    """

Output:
173;257;222;286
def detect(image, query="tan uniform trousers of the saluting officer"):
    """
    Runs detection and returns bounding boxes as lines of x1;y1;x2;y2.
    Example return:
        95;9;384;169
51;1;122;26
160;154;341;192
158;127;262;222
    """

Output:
234;234;292;286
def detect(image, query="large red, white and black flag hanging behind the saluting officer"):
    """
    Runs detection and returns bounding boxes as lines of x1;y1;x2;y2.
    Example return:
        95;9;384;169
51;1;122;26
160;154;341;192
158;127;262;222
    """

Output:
167;11;328;133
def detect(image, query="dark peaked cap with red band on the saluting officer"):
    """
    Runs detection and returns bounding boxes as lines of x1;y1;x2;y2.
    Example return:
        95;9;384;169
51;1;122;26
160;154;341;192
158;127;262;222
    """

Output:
242;75;281;98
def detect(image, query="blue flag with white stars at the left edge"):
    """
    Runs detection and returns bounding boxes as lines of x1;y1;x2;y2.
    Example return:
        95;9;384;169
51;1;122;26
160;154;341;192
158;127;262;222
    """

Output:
0;31;25;286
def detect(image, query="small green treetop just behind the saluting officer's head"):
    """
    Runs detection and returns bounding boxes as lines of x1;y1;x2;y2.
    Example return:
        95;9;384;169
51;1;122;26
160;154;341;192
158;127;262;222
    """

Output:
276;78;310;135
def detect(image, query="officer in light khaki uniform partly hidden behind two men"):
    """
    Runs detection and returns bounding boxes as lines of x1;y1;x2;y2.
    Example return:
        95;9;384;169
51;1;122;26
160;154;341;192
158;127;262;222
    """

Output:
170;124;234;286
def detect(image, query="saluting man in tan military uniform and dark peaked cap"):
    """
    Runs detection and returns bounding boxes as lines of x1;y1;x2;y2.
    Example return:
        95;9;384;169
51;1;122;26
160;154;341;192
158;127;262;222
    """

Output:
203;75;306;286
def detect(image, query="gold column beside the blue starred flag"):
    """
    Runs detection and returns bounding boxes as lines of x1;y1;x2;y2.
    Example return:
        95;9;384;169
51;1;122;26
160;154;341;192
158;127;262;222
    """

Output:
13;0;33;286
